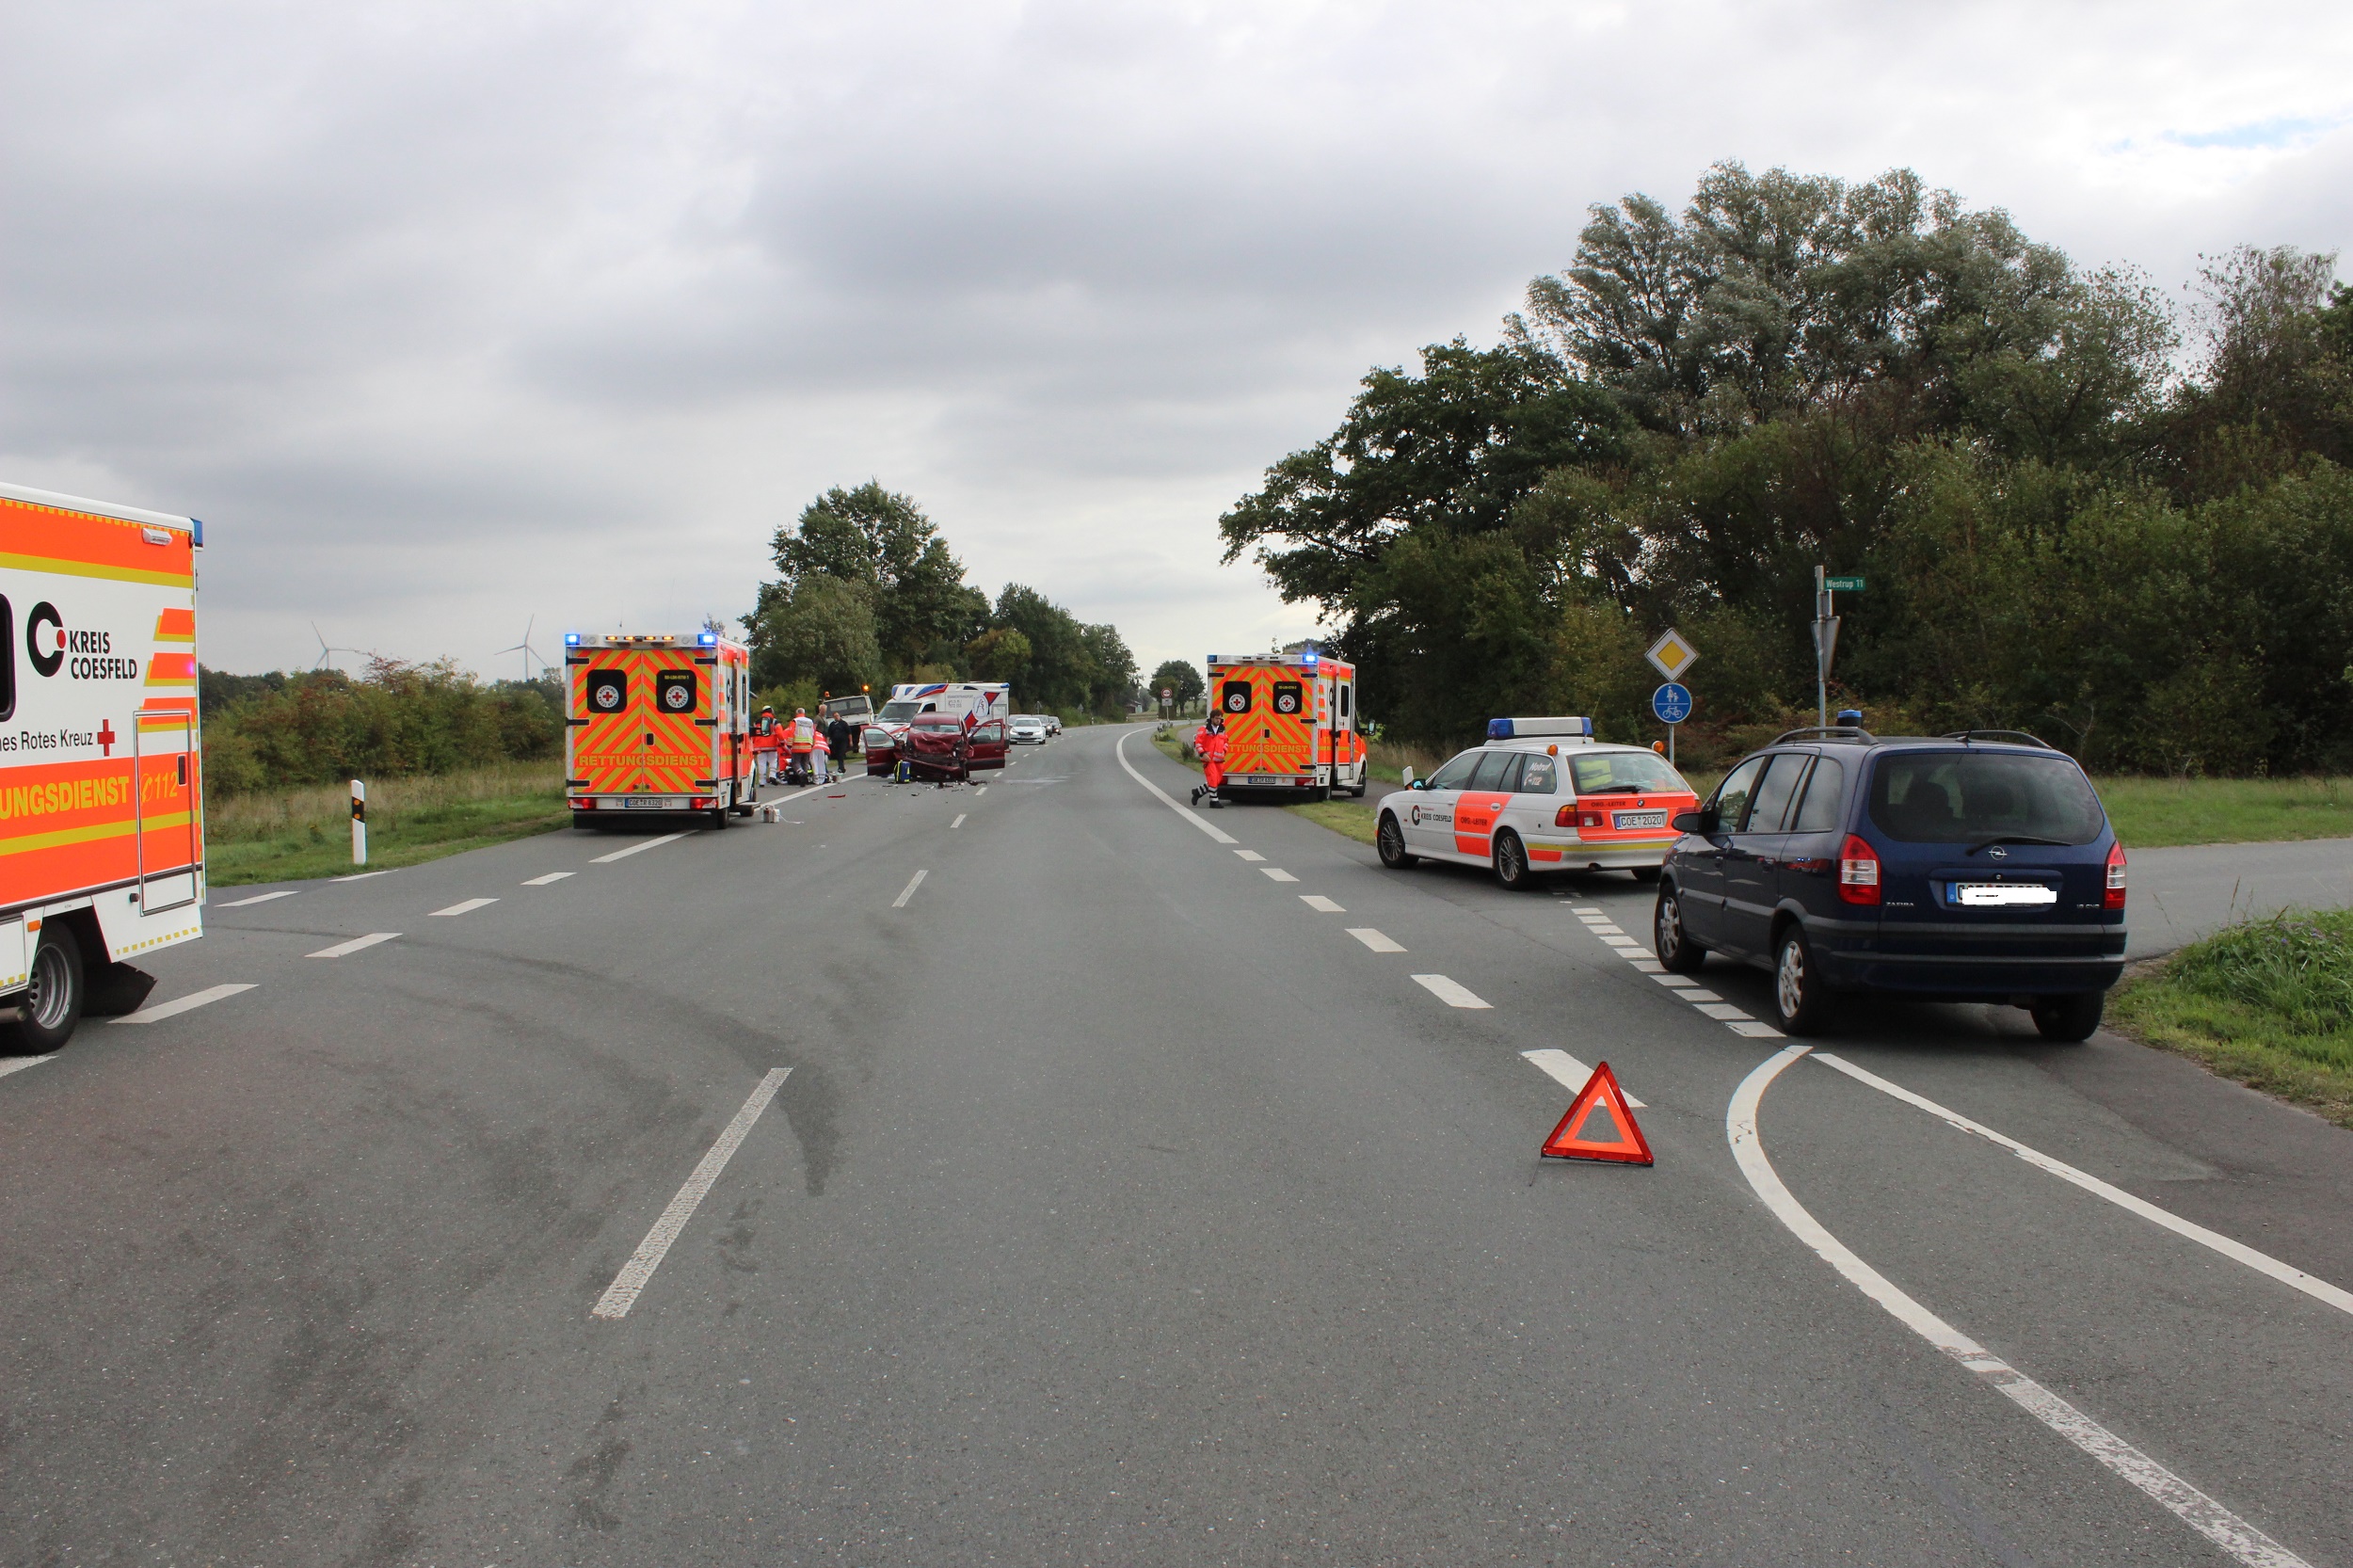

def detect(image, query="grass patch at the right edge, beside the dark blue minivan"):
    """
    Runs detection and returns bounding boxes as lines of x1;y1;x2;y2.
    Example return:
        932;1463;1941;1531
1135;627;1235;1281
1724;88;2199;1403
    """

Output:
2108;909;2353;1128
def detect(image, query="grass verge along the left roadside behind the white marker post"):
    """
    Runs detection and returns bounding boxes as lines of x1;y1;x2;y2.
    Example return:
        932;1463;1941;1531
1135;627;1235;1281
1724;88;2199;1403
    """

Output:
205;760;572;888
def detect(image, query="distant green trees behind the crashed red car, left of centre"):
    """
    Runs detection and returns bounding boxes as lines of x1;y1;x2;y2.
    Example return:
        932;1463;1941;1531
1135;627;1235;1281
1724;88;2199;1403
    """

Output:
744;480;1137;715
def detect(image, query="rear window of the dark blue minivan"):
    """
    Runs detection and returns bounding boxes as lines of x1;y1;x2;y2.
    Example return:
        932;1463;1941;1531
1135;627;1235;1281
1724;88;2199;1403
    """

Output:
1871;751;2108;843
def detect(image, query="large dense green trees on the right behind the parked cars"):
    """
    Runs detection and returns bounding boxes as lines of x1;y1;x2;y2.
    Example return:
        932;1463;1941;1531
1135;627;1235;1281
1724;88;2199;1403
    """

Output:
1222;163;2353;775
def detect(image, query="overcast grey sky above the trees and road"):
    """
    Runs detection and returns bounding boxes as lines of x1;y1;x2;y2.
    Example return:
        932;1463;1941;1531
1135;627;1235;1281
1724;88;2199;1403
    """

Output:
0;0;2353;673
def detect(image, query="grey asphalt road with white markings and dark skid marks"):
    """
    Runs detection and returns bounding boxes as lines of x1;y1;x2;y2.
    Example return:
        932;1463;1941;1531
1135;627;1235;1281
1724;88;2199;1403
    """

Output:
0;729;2353;1568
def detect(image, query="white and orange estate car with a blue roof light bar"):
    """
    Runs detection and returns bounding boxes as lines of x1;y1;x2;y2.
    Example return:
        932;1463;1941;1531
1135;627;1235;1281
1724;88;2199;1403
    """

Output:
1374;718;1699;888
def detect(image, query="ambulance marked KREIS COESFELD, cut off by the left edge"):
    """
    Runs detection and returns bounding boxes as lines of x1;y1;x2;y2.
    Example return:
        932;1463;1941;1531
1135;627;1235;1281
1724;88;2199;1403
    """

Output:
0;471;205;1052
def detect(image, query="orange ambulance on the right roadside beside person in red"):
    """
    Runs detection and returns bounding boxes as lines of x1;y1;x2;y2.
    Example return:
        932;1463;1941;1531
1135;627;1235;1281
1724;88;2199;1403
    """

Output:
1209;648;1369;801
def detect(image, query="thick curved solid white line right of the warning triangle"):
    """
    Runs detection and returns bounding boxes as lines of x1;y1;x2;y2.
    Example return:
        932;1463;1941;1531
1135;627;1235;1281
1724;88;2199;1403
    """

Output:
1725;1046;2311;1568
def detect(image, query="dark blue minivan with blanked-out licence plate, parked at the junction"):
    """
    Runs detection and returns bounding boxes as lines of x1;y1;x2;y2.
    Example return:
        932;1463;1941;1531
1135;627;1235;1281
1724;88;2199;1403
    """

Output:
1652;728;2125;1041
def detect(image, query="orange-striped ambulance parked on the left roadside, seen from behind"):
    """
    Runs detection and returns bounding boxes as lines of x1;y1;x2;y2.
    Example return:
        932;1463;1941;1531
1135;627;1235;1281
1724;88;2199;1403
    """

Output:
565;631;760;829
